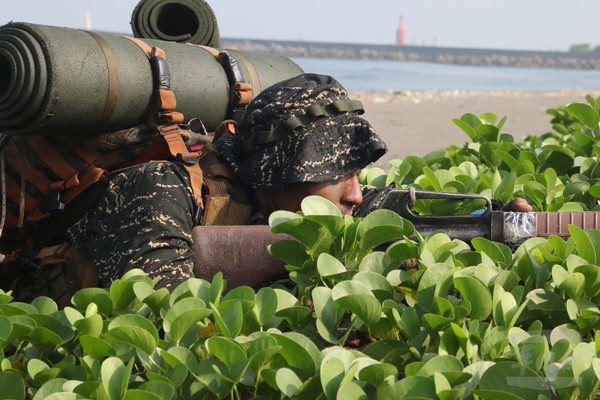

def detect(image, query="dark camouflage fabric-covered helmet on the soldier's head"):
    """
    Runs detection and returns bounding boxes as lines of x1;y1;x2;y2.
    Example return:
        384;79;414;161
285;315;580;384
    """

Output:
216;74;387;192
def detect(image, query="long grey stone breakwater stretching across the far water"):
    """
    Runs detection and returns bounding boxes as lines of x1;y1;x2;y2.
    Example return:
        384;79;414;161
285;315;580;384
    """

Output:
222;38;600;70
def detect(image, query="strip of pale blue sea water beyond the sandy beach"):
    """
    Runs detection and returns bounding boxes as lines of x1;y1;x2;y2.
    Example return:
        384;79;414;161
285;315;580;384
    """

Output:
292;57;600;91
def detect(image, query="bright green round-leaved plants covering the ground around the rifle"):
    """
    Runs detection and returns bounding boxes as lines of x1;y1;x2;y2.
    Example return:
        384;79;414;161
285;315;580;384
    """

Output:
0;98;600;400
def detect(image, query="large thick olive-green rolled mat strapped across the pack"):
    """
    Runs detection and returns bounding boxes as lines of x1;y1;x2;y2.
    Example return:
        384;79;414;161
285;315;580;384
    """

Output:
0;23;302;135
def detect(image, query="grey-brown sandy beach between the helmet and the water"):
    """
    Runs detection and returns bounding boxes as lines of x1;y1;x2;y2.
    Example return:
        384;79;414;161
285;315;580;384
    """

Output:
350;90;600;167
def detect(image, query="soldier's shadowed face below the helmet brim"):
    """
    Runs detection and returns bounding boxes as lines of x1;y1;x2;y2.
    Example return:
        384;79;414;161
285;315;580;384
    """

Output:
259;171;362;215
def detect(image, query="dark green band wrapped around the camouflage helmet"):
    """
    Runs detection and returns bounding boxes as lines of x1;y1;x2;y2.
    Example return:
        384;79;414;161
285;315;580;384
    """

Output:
235;100;364;153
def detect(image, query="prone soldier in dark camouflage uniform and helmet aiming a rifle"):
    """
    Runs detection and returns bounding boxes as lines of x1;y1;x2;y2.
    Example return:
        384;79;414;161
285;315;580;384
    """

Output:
67;74;387;290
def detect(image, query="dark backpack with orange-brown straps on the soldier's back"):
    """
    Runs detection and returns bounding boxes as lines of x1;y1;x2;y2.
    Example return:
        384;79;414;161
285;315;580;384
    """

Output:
0;42;252;306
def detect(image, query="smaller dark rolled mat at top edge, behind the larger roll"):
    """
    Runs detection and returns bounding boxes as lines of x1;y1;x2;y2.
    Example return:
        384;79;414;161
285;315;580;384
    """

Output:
131;0;221;47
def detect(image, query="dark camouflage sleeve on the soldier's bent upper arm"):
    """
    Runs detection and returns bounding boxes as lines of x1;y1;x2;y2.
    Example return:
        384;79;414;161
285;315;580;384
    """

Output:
67;161;196;290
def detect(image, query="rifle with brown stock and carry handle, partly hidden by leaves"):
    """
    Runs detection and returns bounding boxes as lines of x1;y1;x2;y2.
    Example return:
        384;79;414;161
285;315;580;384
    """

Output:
193;189;600;287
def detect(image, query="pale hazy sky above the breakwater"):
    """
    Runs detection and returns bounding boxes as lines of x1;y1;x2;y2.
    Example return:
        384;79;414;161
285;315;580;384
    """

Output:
0;0;600;51
